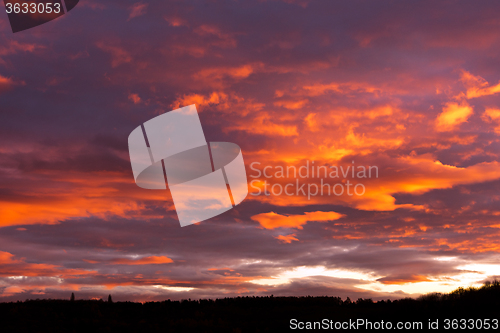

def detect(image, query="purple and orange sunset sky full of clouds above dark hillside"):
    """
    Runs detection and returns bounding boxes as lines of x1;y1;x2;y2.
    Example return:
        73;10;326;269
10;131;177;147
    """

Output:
0;0;500;302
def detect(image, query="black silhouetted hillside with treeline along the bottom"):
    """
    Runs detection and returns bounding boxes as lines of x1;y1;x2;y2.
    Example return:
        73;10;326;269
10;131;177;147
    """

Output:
0;281;500;332
